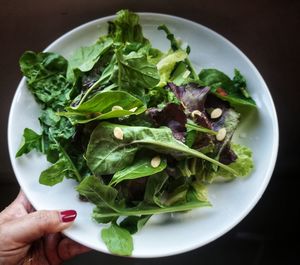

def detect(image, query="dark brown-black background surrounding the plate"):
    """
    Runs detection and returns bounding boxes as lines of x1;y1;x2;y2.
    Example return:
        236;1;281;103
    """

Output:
0;0;300;265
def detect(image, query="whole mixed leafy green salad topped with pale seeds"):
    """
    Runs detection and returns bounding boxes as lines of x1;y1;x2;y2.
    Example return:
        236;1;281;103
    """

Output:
16;10;256;255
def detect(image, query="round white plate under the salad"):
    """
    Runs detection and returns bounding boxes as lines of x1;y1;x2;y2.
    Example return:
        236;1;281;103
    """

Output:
8;13;278;257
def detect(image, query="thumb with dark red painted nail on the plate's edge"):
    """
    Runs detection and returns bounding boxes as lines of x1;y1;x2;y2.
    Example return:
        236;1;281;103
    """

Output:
5;210;77;243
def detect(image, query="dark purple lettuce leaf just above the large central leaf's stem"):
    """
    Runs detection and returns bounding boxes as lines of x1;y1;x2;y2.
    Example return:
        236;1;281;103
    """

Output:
148;103;187;142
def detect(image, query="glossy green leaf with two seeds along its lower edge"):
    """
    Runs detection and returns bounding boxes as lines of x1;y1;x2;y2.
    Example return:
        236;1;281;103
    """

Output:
59;91;146;124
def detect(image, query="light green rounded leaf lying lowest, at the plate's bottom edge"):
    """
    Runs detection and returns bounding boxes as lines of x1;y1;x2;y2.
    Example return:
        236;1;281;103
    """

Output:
101;223;133;256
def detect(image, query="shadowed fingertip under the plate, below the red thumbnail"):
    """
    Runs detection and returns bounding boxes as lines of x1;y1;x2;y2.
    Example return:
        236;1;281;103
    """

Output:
58;238;91;260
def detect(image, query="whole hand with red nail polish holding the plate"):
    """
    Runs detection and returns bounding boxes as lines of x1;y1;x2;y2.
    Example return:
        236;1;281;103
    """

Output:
0;191;90;265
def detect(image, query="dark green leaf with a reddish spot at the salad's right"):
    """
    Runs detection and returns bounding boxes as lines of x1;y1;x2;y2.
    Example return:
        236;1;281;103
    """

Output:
199;69;256;107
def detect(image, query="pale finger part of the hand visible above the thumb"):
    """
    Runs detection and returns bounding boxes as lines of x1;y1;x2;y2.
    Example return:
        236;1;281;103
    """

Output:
0;190;32;224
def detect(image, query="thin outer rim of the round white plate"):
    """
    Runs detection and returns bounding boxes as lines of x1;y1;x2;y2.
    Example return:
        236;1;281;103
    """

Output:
7;12;279;258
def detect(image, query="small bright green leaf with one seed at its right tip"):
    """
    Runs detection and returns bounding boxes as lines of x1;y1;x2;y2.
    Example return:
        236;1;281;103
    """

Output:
110;156;167;185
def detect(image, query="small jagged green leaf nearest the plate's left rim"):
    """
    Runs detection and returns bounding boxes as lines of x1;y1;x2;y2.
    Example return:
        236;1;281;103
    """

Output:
16;128;42;157
